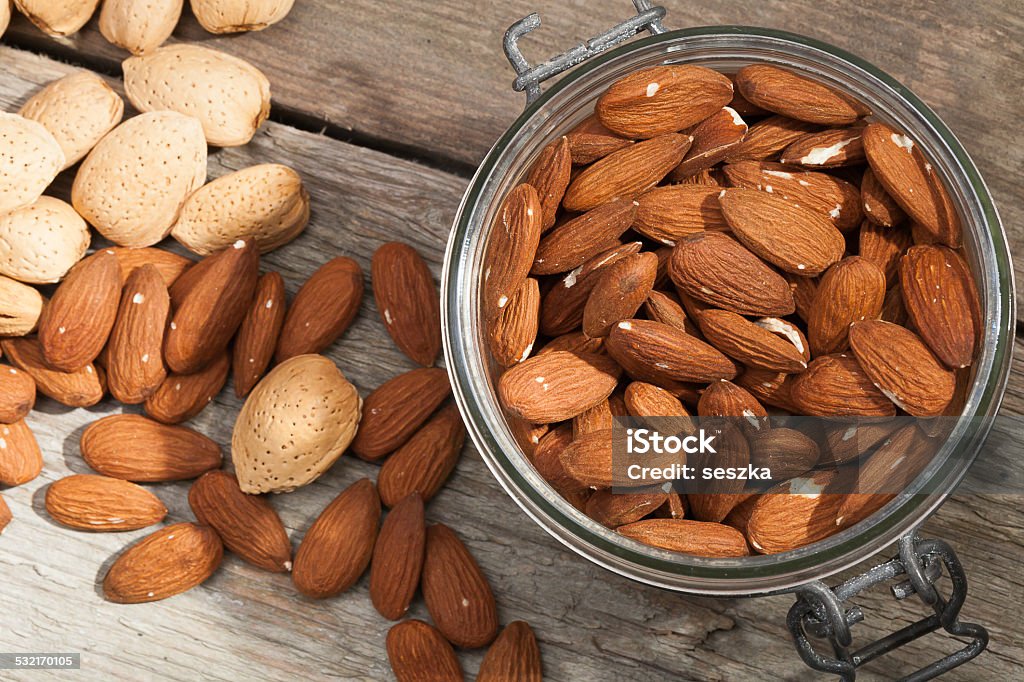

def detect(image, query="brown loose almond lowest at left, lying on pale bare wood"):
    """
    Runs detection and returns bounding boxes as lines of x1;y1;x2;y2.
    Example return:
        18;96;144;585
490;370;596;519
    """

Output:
103;523;224;604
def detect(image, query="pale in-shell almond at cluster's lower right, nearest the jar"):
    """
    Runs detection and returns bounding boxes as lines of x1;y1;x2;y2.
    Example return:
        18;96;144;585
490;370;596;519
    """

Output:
171;164;309;256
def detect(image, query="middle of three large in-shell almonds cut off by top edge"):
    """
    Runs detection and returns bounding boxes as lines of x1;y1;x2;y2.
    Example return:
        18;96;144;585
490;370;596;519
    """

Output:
99;0;184;54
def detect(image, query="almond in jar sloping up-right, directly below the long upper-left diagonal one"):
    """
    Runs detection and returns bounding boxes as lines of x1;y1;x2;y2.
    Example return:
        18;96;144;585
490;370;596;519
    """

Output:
530;193;637;274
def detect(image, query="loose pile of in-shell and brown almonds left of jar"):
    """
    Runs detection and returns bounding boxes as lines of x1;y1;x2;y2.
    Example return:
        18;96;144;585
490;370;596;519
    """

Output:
0;0;541;681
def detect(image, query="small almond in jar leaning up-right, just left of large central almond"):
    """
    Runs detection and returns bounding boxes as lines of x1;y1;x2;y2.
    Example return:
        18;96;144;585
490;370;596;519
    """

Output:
583;252;657;338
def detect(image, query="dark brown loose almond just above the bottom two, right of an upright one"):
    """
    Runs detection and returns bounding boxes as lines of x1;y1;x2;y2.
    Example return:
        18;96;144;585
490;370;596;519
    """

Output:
421;523;498;649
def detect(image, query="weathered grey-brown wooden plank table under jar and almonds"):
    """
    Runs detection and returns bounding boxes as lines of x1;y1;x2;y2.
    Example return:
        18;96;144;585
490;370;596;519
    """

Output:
0;0;1024;680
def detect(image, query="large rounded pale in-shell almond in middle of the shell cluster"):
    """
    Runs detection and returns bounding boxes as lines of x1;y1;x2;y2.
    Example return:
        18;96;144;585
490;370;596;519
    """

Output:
71;112;206;247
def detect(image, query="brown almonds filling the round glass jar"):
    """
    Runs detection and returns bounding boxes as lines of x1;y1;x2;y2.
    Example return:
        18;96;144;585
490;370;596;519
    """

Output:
480;65;982;556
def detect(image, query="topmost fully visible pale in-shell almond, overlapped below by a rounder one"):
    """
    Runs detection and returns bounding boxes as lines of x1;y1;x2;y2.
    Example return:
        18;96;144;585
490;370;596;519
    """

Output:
122;44;270;146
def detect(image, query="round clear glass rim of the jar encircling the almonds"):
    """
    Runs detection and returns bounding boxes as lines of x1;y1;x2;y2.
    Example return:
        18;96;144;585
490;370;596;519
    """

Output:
442;27;1015;595
